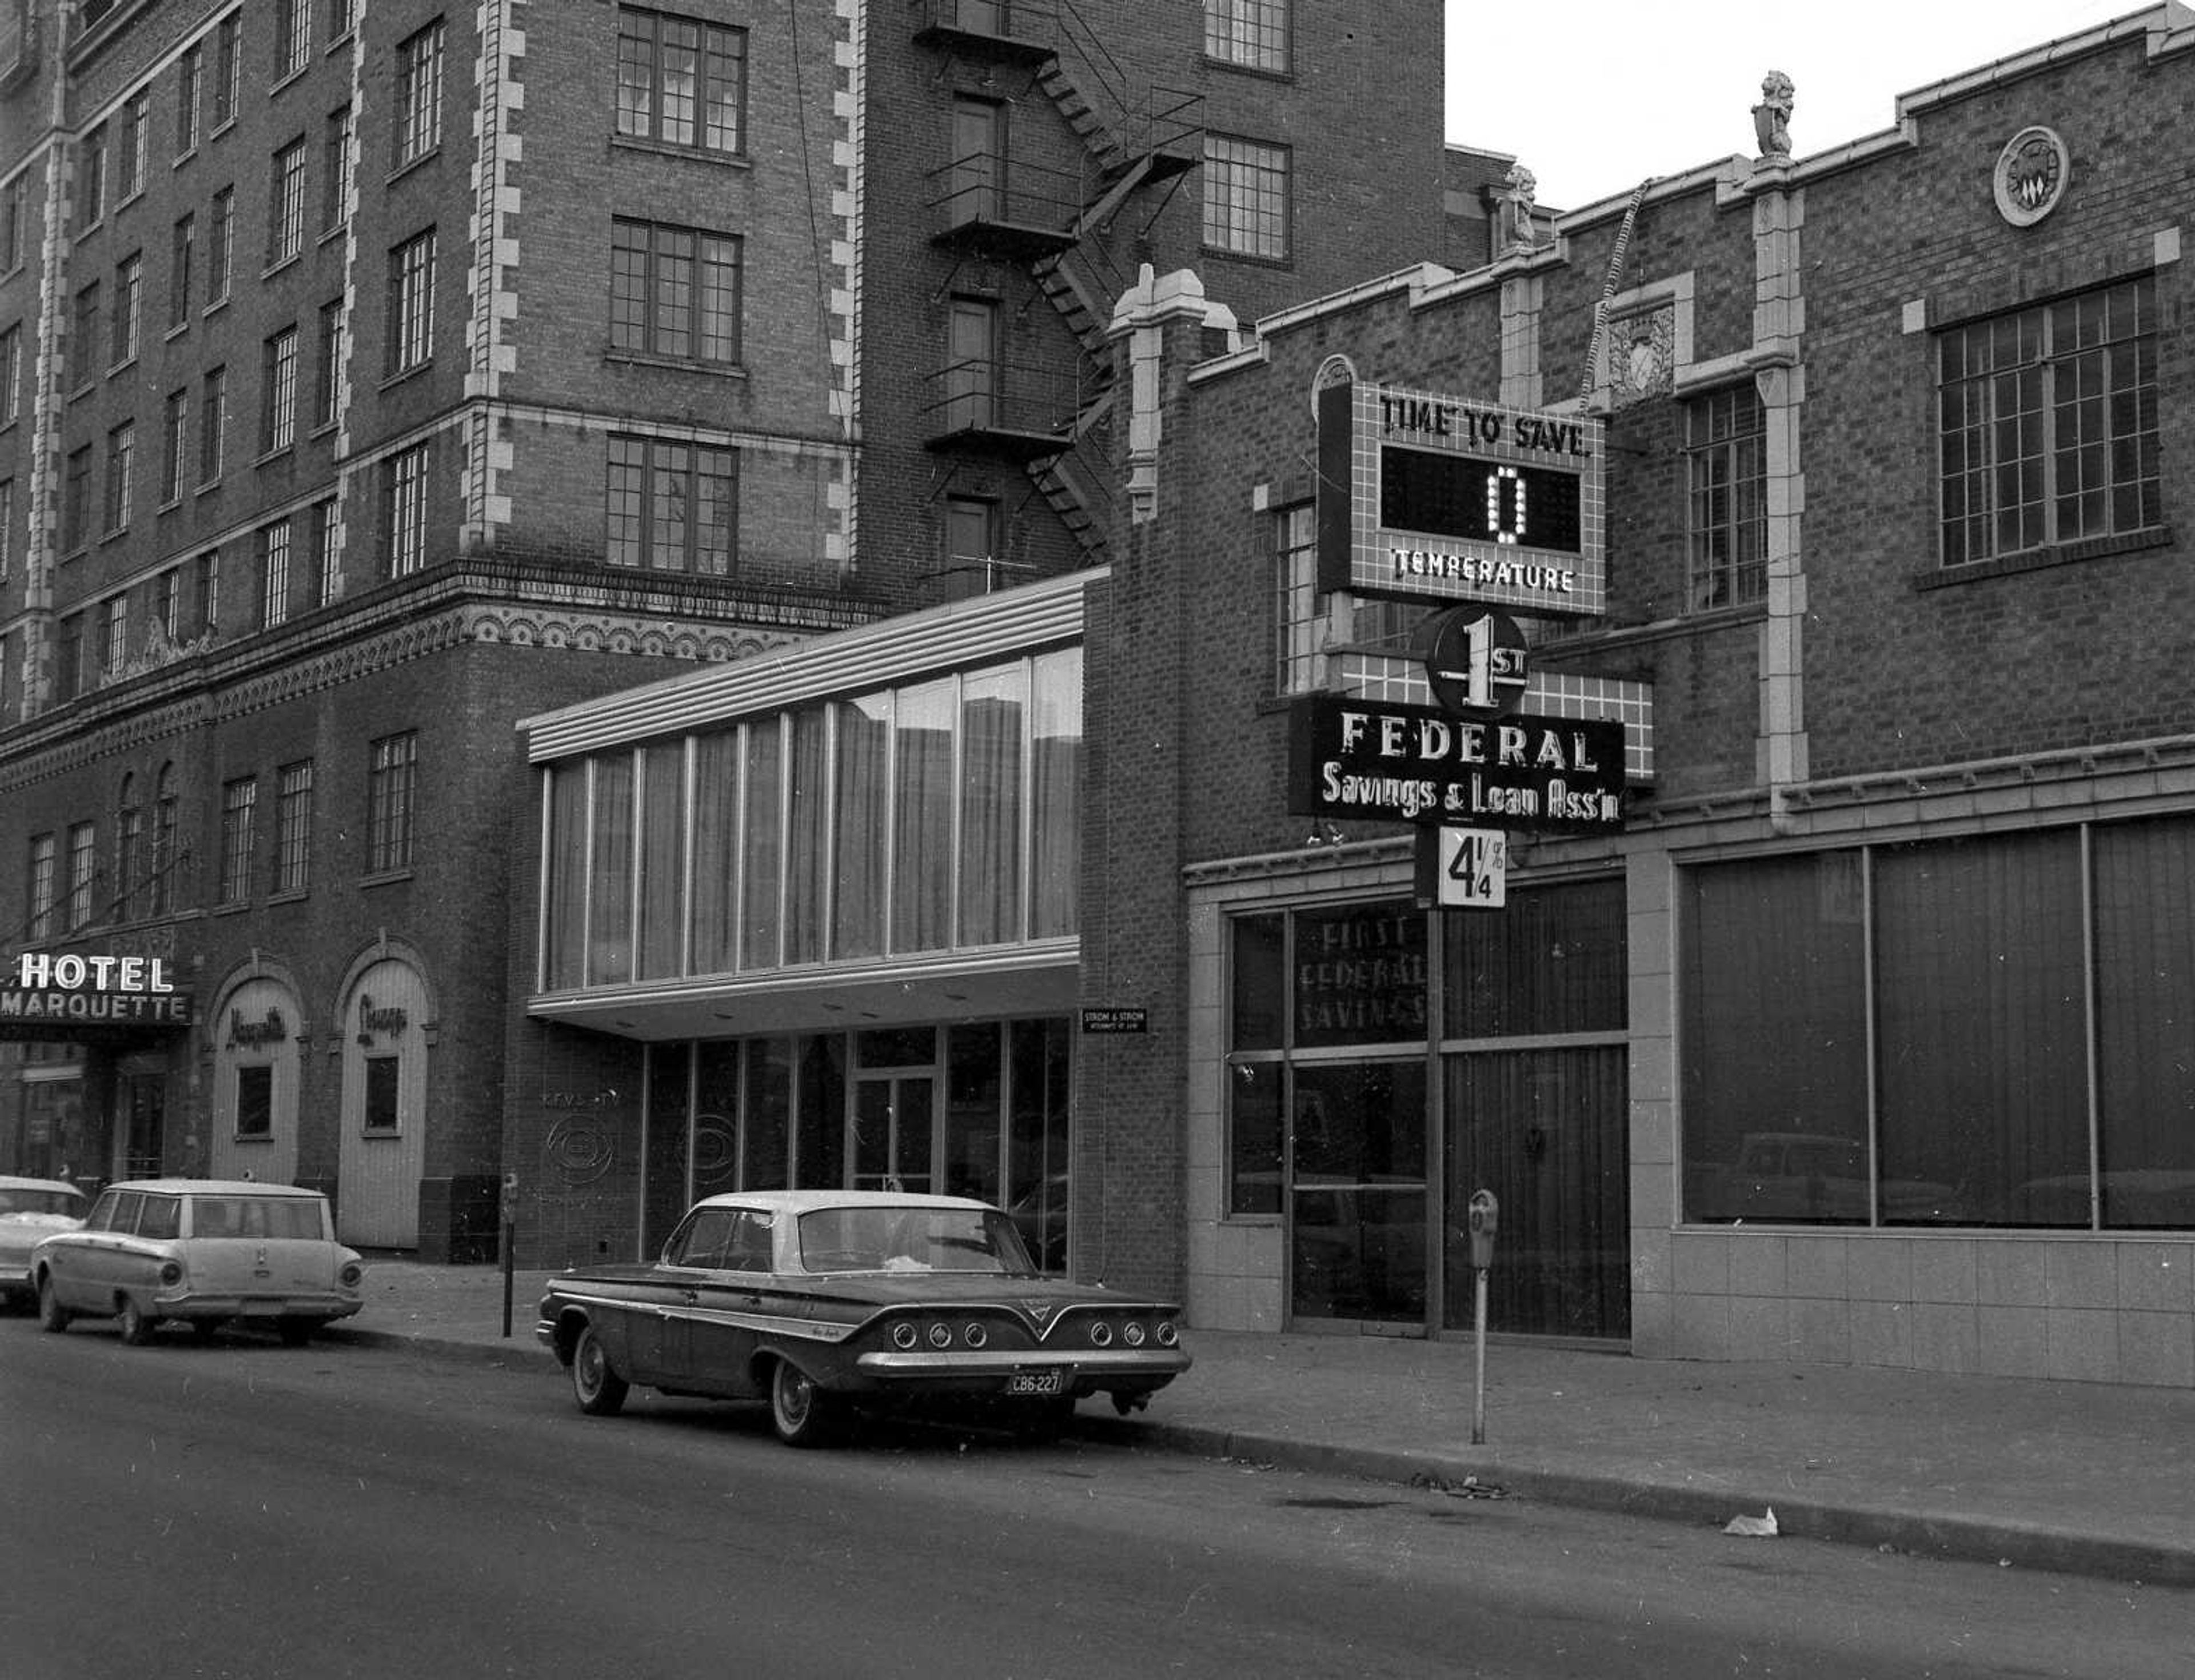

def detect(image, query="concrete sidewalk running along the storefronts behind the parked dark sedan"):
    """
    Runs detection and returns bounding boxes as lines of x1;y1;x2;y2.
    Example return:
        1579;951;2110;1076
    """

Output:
327;1260;2195;1586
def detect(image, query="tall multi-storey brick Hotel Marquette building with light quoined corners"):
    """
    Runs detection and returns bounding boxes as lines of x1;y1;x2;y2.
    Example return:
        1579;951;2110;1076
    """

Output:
0;0;1473;1258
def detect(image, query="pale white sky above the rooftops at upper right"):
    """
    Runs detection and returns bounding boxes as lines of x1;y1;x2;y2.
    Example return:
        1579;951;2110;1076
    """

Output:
1447;0;2145;211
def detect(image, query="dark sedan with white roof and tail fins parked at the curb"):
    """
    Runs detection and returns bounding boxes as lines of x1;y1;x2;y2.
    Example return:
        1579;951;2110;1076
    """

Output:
536;1190;1190;1447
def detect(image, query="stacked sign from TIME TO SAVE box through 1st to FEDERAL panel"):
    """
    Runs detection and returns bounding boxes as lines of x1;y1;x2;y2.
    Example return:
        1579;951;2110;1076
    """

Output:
1288;380;1625;835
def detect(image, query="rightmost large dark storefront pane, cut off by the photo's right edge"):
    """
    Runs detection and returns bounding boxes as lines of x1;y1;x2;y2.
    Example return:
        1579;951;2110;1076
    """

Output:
2094;817;2195;1230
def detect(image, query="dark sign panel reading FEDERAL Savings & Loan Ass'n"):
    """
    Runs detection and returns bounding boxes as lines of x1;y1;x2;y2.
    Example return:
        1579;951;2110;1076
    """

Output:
1288;694;1625;835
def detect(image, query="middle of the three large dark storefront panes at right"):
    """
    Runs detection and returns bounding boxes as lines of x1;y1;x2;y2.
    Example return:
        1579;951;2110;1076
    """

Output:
1874;828;2088;1226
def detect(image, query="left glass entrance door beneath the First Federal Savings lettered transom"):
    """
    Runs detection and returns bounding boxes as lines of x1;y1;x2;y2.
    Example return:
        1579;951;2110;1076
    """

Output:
1288;1059;1427;1331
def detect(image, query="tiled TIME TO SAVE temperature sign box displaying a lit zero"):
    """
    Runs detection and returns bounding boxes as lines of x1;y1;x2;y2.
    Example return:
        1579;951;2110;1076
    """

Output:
1315;382;1607;615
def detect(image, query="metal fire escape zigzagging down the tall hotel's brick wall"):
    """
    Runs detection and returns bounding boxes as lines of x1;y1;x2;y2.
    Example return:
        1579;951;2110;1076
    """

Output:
909;0;1203;558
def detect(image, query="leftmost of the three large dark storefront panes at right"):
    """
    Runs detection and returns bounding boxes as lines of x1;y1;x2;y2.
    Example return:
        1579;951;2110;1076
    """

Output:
1679;852;1868;1223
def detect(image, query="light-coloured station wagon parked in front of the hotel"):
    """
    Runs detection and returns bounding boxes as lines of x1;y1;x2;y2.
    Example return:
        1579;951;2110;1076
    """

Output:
31;1179;366;1346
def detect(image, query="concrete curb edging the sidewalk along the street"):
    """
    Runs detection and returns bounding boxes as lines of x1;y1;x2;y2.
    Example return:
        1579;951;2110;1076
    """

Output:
342;1315;2195;1588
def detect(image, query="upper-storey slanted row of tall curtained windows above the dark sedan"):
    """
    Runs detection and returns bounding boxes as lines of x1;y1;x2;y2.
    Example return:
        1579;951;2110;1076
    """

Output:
540;648;1082;991
